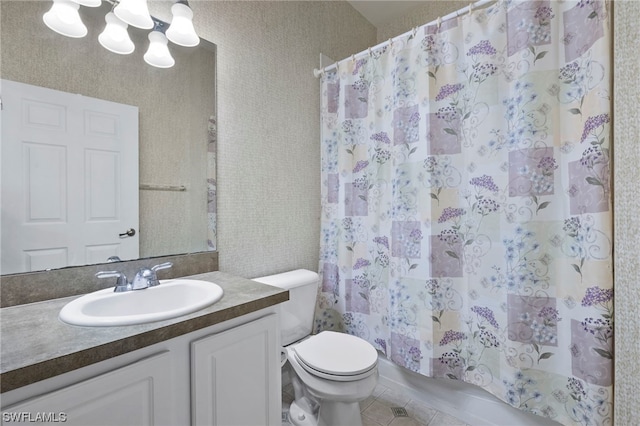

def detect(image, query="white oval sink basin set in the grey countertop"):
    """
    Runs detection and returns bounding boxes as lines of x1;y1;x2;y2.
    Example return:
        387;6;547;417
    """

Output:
60;278;223;327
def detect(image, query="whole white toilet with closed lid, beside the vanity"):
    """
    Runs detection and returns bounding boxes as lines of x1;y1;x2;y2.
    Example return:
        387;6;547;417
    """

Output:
254;269;378;426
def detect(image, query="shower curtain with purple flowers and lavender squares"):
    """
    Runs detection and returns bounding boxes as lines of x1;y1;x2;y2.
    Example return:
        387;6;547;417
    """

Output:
316;0;613;424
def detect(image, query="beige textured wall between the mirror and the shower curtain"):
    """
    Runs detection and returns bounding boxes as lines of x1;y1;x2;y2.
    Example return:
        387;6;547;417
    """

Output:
190;1;375;277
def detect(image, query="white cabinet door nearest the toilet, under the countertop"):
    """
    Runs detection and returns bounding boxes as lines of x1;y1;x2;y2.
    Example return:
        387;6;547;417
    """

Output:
191;314;282;426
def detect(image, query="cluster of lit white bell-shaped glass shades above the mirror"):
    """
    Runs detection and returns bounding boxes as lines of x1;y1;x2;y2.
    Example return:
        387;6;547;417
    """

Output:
42;0;200;68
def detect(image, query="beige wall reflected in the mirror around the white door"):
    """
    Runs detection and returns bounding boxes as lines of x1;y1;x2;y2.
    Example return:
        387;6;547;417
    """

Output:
0;1;216;274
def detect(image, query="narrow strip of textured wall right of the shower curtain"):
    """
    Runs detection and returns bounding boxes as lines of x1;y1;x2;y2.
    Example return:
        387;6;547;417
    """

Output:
613;1;640;425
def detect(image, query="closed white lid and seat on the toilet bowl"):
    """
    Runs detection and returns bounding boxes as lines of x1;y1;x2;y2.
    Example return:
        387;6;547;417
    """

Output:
293;331;378;376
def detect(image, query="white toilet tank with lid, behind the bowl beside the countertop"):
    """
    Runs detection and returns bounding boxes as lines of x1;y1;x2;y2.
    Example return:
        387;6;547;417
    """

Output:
253;269;320;346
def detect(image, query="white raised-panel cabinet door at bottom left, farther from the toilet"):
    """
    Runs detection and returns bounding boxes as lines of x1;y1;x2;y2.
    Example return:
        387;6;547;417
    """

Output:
2;351;178;426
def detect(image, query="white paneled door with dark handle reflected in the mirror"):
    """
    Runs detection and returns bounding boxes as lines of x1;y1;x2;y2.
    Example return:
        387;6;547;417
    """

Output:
0;80;139;274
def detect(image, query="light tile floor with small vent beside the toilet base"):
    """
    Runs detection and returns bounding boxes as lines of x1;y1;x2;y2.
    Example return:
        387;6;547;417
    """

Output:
282;384;467;426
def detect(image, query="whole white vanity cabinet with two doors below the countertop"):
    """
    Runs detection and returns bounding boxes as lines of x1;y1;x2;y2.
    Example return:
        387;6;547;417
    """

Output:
2;308;282;426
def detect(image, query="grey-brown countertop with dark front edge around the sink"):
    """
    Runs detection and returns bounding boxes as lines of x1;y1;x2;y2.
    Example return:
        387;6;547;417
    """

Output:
0;272;289;392
